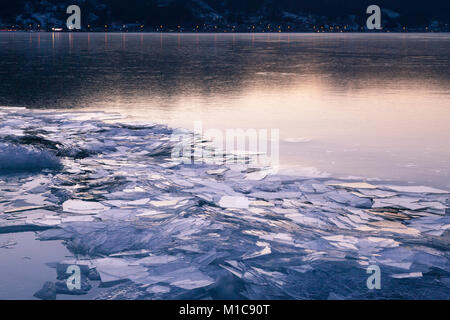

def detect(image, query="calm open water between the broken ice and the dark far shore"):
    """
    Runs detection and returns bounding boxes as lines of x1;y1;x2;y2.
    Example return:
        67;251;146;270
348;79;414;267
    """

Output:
0;33;450;189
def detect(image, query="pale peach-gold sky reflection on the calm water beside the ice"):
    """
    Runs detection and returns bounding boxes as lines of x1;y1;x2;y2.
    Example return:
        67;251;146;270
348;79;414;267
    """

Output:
79;71;450;187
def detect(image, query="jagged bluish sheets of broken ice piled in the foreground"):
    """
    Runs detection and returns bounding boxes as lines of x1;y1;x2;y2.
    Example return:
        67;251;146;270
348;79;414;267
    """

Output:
0;109;450;299
